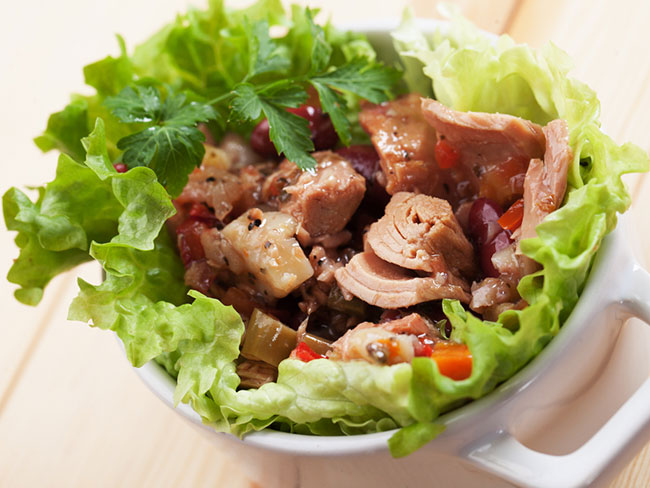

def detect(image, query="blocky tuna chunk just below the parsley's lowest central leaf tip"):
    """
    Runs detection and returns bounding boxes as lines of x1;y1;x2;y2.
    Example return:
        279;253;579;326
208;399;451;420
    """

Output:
280;151;366;237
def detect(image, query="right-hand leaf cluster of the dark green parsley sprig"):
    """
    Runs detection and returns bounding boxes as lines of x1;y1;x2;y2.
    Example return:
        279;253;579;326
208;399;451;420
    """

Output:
223;16;400;169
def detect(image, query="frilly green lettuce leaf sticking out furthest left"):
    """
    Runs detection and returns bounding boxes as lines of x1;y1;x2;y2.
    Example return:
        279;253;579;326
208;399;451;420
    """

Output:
3;119;175;305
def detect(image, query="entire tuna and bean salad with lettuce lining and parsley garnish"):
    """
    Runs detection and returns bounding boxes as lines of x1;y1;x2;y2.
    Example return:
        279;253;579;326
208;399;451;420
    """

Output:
3;0;648;456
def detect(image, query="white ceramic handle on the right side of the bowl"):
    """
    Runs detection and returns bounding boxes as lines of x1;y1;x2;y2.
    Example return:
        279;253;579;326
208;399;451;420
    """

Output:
458;263;650;488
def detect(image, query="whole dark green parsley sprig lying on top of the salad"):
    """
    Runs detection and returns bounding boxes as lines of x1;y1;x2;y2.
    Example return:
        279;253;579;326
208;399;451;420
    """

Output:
105;9;400;196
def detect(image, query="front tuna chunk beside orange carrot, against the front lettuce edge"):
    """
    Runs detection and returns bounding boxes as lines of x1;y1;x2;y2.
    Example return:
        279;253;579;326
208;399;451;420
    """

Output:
327;313;437;365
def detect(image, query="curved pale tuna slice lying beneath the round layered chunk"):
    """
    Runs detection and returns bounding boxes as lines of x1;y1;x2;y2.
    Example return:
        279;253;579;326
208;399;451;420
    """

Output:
335;251;470;309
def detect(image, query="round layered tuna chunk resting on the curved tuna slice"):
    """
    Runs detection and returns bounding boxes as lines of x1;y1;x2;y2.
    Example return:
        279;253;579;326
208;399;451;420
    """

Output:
366;192;476;276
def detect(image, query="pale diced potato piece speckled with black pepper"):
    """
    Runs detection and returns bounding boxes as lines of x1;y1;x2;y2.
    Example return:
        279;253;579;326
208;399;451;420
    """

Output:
222;208;314;298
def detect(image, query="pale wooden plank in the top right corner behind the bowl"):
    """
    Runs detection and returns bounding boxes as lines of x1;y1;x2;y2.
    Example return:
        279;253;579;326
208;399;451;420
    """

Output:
508;0;650;194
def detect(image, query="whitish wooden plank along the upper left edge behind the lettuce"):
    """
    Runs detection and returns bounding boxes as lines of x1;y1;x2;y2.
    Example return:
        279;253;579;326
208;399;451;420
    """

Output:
0;0;197;398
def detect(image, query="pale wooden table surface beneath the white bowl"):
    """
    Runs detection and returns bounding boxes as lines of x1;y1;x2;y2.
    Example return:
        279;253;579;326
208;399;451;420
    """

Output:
0;0;650;487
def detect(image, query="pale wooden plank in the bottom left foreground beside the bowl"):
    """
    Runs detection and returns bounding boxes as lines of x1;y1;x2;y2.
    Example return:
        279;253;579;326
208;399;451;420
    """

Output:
0;268;249;487
